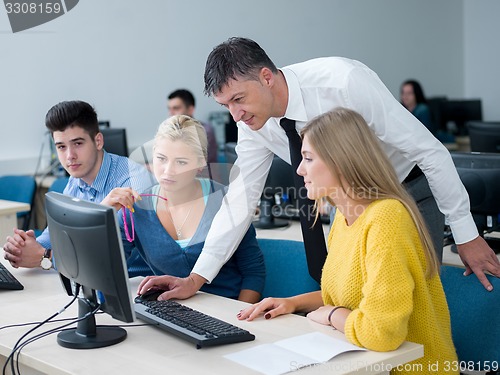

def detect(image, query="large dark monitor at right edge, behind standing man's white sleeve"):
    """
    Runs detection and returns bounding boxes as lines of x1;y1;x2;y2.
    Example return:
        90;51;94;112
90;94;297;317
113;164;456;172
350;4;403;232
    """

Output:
451;152;500;252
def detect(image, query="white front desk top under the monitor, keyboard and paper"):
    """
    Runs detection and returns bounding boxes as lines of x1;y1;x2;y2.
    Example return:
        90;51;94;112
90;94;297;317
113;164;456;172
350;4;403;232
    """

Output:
0;259;423;375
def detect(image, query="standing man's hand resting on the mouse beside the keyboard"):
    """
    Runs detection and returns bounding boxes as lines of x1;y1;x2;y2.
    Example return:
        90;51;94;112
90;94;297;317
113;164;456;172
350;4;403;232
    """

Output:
137;273;207;301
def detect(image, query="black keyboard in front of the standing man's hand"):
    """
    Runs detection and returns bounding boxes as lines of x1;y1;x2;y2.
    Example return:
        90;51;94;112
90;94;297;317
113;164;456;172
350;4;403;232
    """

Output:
135;301;255;349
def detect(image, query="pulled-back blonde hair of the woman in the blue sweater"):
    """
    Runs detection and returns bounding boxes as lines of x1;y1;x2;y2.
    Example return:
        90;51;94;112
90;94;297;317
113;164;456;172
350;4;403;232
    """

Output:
153;115;208;164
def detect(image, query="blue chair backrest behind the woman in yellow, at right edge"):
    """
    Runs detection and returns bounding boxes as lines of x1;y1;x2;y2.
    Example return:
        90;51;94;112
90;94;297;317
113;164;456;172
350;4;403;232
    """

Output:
441;266;500;371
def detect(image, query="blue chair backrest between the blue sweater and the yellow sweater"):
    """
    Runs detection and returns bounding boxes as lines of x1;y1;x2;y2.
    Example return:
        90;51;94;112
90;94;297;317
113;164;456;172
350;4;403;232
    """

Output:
257;238;320;298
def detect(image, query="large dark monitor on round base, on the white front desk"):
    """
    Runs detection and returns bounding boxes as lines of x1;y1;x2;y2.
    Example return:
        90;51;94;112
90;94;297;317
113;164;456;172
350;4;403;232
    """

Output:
45;192;135;349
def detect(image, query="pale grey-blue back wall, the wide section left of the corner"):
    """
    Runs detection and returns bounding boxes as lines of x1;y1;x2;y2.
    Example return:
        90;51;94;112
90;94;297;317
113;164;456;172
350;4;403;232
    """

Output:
0;0;470;174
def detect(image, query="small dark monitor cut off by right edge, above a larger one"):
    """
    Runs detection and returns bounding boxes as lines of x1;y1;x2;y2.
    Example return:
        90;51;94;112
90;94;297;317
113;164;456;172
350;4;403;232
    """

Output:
467;121;500;152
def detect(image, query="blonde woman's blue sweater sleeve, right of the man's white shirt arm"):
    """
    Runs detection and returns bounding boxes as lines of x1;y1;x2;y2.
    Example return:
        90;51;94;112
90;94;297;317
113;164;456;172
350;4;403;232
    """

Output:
233;225;266;293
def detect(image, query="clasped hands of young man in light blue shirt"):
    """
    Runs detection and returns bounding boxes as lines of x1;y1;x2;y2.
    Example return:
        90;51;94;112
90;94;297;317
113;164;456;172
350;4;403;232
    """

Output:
3;229;45;268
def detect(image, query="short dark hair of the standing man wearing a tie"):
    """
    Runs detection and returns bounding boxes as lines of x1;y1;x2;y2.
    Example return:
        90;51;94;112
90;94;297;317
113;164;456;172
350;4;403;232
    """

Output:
204;37;278;96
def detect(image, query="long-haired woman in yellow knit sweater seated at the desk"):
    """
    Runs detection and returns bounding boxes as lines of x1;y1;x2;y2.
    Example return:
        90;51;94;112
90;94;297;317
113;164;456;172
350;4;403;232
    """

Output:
238;108;458;374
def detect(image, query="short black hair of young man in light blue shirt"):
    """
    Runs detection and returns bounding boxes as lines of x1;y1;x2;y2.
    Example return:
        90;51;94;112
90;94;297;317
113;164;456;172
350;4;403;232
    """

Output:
45;100;99;139
